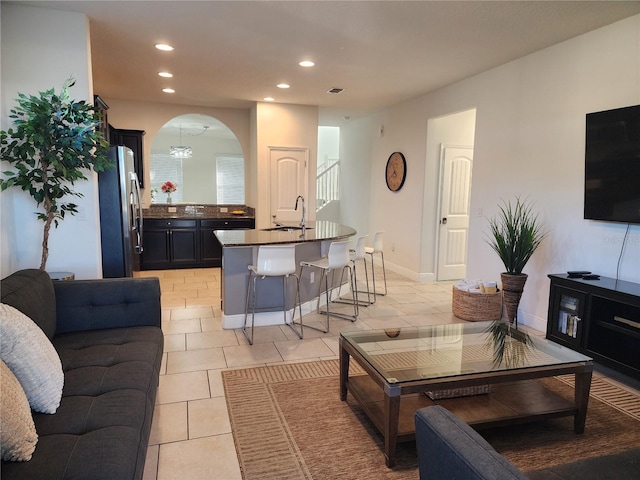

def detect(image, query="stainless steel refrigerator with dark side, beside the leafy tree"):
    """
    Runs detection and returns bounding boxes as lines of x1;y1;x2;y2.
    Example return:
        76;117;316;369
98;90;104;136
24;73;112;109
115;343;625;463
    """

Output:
98;146;143;278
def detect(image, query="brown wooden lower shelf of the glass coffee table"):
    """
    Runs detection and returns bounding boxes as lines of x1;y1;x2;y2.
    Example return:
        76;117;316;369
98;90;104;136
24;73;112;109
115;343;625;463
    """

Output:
347;375;578;442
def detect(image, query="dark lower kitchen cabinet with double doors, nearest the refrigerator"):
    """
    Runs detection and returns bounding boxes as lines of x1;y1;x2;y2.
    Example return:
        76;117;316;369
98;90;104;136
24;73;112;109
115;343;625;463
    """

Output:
142;219;199;270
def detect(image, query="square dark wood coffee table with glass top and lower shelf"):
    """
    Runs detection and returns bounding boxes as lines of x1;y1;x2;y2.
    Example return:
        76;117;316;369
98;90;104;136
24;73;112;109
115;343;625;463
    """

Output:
339;322;593;467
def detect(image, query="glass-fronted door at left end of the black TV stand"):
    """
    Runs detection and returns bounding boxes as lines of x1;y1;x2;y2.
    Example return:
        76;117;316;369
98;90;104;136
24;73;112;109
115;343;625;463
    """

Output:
547;286;587;347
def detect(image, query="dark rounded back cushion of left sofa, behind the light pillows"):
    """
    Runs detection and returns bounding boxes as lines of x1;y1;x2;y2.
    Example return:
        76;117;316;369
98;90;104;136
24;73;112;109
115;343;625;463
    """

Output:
0;269;56;339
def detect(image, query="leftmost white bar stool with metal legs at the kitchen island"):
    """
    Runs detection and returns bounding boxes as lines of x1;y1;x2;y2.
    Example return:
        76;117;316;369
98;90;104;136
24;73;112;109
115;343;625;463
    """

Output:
242;245;302;345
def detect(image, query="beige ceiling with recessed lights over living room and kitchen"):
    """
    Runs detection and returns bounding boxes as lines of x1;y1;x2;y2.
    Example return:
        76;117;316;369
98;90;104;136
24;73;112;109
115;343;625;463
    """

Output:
15;0;640;124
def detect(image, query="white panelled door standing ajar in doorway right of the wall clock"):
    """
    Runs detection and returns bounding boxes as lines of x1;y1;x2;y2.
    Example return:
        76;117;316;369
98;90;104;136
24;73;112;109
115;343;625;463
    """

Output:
437;145;473;280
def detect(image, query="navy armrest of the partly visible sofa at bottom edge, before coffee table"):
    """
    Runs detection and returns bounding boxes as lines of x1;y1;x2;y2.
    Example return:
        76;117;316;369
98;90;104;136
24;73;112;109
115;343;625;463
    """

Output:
415;406;527;480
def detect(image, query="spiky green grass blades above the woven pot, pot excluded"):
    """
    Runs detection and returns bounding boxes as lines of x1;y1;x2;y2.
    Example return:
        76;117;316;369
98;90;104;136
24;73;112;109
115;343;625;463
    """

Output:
487;197;547;275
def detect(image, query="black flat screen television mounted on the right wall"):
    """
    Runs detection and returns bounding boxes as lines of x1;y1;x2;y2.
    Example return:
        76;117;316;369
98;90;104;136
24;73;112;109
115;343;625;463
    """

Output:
584;105;640;224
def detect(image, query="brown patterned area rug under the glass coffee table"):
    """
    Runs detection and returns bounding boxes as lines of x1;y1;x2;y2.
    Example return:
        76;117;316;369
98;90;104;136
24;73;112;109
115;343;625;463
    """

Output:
222;360;640;480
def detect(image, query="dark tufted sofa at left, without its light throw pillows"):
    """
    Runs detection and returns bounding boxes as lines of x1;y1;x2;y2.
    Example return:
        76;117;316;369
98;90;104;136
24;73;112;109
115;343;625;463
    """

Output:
0;270;164;480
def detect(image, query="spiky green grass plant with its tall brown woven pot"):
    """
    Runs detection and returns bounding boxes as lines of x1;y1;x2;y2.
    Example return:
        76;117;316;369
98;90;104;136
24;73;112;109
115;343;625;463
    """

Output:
487;197;547;324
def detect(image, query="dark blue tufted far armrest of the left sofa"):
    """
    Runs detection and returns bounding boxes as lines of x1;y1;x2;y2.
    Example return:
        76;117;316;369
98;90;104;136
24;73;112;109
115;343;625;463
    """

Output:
54;277;161;335
